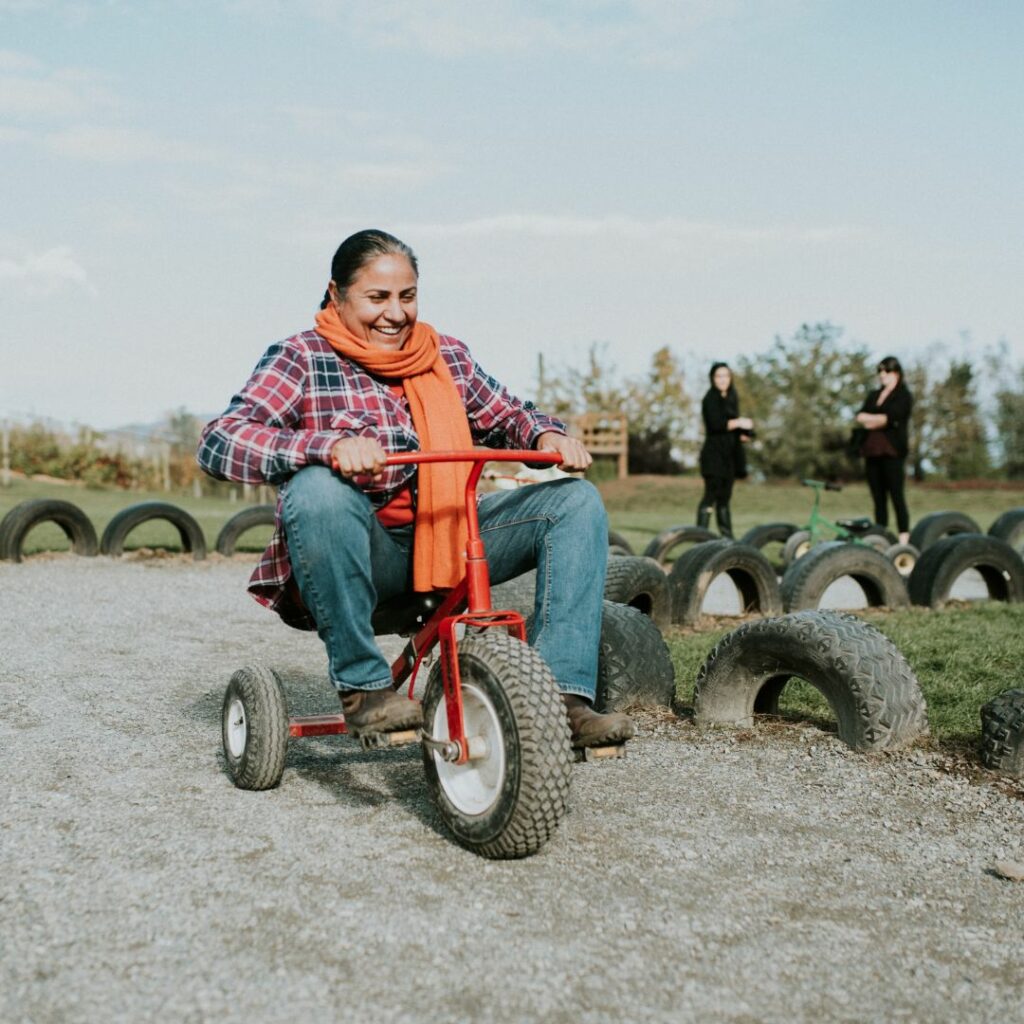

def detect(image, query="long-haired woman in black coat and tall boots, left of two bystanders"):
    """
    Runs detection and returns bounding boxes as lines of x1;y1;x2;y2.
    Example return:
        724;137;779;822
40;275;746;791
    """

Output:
697;362;754;539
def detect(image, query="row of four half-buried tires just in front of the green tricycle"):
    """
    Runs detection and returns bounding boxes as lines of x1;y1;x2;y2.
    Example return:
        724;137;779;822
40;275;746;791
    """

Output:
604;534;1024;628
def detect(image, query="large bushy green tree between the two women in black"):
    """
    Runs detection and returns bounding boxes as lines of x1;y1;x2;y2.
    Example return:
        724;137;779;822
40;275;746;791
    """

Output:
735;323;873;479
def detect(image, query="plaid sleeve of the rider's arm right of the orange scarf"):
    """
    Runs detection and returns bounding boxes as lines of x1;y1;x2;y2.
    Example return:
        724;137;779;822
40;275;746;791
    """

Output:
441;338;566;449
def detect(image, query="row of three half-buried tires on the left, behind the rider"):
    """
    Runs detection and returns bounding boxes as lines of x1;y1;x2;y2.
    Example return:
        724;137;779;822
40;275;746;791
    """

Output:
0;499;274;562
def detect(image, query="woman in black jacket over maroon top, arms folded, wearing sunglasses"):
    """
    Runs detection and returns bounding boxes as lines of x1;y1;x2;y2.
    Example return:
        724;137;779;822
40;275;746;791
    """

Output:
857;355;913;544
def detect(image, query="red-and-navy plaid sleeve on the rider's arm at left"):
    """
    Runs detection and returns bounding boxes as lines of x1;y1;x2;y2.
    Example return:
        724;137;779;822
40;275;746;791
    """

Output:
196;342;341;484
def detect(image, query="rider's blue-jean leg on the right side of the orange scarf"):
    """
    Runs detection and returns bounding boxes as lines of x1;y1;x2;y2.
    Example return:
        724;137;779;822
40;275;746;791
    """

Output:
479;479;608;700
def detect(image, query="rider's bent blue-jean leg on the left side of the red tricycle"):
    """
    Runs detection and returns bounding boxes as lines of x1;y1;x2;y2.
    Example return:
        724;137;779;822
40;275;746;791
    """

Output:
282;466;412;690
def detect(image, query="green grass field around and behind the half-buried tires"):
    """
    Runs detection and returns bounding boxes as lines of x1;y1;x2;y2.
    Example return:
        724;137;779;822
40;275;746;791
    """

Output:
0;476;1024;749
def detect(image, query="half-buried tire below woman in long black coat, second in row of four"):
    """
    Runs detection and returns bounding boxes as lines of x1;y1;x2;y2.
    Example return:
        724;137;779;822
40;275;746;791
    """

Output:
669;541;782;626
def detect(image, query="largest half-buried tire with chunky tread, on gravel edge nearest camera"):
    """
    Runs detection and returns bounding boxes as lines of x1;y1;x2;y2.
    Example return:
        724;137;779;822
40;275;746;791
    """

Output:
694;611;928;751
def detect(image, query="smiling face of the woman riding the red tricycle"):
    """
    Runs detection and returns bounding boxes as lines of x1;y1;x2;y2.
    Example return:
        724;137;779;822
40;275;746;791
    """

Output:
329;253;418;349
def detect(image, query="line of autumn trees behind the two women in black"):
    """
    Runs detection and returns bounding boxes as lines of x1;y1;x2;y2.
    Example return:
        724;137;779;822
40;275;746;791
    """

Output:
538;322;1024;480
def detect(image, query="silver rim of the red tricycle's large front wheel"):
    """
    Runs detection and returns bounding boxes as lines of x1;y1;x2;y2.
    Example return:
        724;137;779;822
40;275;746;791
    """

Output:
430;682;505;816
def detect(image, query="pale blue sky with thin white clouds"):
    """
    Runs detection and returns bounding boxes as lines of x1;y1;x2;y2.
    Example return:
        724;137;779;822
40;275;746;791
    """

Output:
0;0;1024;427
